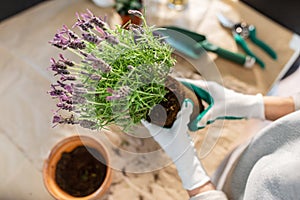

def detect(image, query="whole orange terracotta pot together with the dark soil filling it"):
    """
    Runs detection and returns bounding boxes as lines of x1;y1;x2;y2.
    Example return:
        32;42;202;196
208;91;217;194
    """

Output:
43;136;112;200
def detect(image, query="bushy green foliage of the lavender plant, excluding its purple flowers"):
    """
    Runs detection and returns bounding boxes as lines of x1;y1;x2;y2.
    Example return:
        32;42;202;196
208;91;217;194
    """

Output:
89;17;174;128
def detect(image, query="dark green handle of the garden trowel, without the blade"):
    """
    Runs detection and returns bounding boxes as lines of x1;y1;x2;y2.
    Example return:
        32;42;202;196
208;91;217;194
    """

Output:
196;40;246;65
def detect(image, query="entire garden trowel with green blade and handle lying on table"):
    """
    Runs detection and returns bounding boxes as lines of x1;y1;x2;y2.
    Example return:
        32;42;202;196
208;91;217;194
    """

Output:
156;26;255;68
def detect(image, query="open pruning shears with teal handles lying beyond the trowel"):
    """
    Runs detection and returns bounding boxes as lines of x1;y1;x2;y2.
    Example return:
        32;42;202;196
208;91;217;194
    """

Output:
217;13;277;68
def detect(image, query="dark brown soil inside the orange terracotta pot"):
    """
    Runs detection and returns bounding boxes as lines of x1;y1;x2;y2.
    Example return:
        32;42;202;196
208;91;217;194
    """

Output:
55;146;107;197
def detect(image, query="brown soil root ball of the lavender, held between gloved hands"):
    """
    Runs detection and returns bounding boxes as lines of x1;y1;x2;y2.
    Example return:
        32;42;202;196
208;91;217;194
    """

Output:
147;76;204;128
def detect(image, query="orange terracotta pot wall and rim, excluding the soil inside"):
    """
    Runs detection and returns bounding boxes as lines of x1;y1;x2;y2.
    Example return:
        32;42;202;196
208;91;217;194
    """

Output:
43;136;112;200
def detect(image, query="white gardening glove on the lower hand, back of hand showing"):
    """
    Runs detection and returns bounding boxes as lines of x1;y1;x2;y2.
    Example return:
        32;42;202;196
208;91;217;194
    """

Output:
142;99;210;190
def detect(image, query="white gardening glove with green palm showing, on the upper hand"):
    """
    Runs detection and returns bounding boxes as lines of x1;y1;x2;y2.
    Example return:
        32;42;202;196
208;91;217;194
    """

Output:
177;79;265;131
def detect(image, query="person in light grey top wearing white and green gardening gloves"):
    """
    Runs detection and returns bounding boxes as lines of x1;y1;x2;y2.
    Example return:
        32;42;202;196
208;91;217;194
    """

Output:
142;80;300;200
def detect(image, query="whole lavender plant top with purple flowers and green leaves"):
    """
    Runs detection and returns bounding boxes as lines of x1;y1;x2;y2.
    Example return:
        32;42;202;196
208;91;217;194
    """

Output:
48;10;175;130
